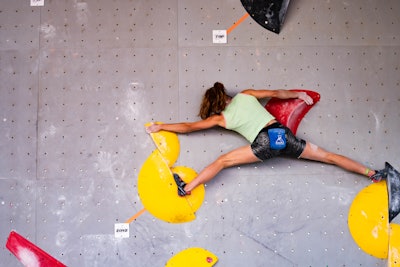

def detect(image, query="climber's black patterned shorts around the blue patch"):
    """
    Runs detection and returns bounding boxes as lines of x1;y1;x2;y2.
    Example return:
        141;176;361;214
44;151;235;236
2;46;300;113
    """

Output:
251;122;306;161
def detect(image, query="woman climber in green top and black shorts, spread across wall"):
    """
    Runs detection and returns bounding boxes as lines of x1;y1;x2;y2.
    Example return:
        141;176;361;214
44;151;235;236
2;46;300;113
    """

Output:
146;82;386;196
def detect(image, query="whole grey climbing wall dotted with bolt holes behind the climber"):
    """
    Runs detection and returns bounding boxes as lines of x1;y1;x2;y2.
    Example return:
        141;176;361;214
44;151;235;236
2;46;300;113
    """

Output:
0;0;400;266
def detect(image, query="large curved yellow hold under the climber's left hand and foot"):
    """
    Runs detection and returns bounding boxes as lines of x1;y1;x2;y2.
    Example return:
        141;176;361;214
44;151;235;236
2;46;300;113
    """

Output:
138;123;205;223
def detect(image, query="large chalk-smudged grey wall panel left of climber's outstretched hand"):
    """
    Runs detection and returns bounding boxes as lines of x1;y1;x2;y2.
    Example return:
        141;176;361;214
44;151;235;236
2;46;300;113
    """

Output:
38;48;177;181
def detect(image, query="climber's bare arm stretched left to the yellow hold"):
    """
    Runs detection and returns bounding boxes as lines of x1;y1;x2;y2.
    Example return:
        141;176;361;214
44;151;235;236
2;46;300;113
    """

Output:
146;115;225;133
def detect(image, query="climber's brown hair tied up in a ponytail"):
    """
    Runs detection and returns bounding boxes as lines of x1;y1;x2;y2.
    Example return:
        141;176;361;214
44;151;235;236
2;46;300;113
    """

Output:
199;82;230;120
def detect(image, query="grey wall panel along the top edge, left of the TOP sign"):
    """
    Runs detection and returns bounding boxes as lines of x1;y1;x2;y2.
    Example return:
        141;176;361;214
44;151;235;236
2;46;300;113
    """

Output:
40;0;177;49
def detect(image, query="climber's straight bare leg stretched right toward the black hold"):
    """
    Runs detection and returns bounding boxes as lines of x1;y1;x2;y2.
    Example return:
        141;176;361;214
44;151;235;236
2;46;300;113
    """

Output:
300;142;375;177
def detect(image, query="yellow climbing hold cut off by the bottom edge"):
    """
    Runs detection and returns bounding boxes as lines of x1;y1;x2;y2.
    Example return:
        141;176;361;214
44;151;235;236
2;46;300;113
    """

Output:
165;248;218;267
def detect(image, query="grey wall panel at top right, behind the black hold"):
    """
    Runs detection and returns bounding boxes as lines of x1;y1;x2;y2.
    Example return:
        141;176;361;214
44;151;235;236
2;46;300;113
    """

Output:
179;0;400;46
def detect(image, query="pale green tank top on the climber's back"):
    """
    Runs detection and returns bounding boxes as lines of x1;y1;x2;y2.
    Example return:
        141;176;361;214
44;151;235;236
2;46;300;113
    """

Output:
222;93;275;143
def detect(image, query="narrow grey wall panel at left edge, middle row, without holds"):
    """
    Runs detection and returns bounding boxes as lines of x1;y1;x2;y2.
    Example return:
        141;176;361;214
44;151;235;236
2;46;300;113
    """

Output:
0;50;38;179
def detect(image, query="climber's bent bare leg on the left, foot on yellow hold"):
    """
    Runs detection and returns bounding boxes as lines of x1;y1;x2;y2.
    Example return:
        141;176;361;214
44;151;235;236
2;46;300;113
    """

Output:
185;146;260;192
